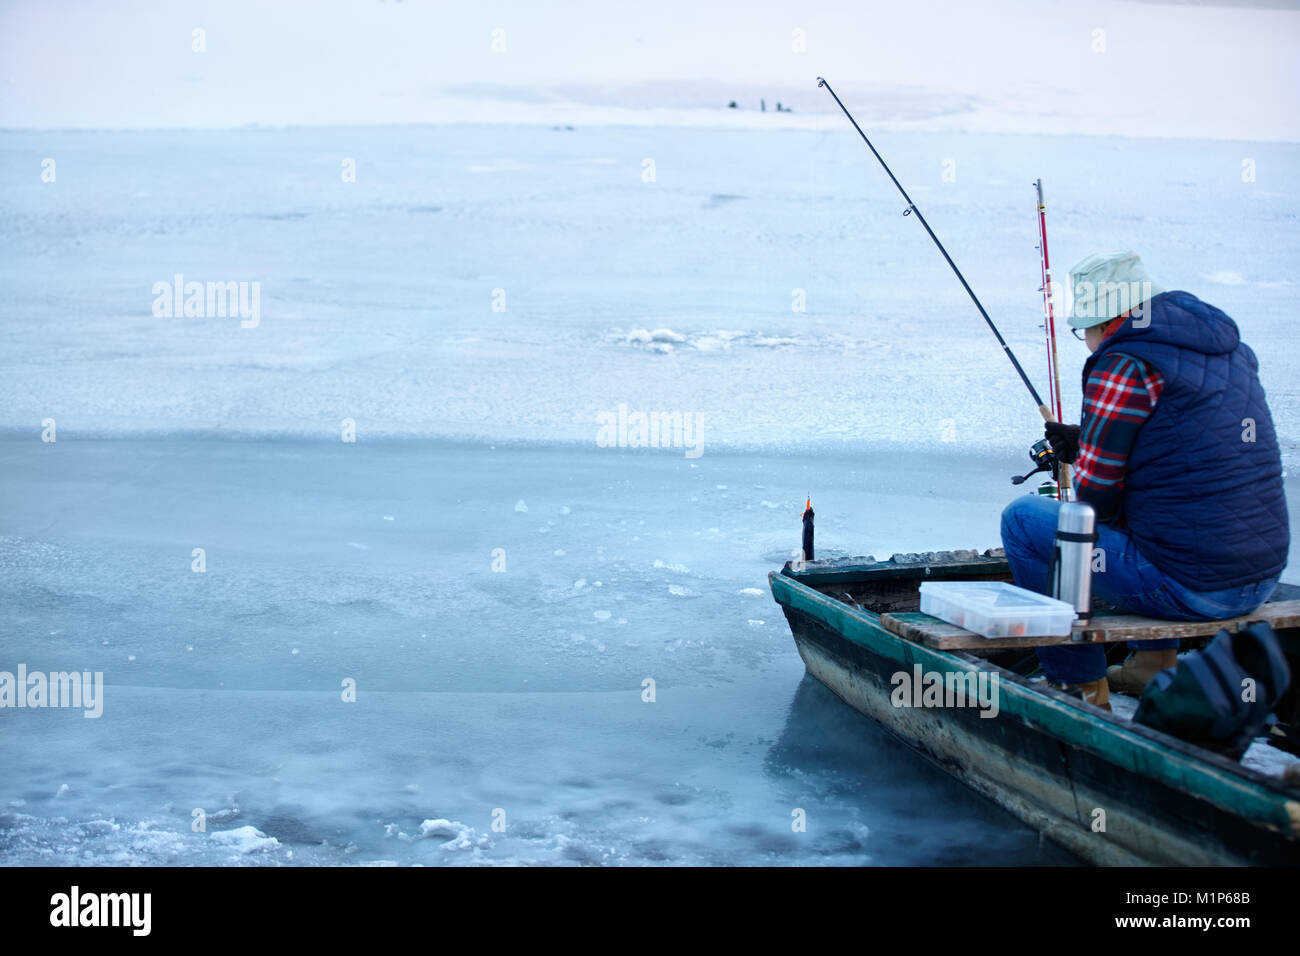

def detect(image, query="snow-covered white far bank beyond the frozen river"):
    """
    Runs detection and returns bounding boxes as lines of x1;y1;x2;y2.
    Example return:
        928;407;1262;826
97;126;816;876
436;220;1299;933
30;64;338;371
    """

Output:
0;0;1300;140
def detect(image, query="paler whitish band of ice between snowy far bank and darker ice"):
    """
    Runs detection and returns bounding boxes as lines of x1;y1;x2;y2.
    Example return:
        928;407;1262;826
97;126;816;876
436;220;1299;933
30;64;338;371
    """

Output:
0;126;1300;468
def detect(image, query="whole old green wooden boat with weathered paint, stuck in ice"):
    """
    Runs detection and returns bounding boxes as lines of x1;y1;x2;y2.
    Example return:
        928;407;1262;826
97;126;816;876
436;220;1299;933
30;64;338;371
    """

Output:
768;550;1300;865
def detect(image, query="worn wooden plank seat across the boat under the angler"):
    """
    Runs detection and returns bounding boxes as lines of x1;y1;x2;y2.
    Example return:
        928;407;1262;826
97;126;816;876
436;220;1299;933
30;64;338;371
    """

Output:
880;600;1300;650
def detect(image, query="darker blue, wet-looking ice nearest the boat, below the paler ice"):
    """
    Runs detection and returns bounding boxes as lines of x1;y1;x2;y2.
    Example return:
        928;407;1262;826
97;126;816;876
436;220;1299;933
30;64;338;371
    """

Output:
0;440;1086;865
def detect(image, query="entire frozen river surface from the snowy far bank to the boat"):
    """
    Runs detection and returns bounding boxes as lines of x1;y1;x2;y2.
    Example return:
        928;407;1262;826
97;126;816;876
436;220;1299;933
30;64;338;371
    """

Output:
0;126;1300;864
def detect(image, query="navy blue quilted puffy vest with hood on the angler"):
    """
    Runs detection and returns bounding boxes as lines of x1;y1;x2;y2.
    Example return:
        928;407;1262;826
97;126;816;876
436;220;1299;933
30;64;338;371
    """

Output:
1083;291;1291;592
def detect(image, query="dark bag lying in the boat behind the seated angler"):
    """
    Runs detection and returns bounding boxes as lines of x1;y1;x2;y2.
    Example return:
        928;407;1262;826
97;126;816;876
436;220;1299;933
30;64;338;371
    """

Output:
1134;622;1291;760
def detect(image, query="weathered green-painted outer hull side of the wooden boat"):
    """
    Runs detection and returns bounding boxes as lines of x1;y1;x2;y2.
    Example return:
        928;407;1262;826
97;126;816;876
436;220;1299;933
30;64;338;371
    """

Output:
768;559;1300;865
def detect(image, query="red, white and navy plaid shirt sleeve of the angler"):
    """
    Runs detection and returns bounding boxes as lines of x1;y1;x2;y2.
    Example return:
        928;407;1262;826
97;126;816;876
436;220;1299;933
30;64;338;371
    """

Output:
1074;352;1165;522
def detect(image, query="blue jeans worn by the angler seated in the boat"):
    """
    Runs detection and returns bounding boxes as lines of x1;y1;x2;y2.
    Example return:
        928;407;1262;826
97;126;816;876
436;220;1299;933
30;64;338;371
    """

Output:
1002;494;1278;684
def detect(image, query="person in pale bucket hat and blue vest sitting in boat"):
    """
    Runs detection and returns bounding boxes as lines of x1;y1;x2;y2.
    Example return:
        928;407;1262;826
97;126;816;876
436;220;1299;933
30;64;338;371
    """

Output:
1002;252;1291;709
